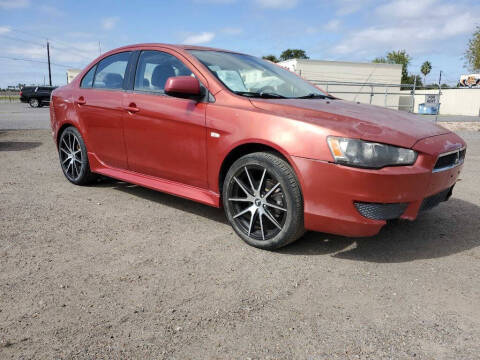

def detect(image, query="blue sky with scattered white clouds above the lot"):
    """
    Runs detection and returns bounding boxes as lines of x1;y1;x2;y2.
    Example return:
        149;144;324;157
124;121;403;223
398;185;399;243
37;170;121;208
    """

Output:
0;0;480;87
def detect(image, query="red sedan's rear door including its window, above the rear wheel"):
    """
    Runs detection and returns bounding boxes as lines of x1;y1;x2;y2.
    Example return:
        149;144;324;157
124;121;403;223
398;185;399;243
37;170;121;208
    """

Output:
74;52;132;169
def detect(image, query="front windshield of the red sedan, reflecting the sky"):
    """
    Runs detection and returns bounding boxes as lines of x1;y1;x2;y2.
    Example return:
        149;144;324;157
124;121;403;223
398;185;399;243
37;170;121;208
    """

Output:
190;50;328;98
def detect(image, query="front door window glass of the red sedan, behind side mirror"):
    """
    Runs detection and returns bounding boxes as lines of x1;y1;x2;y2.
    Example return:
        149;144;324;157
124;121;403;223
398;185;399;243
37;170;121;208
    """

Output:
134;50;193;93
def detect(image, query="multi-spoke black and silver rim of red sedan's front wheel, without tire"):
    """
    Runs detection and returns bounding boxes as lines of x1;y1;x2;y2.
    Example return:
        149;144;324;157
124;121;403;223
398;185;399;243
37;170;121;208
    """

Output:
228;166;287;240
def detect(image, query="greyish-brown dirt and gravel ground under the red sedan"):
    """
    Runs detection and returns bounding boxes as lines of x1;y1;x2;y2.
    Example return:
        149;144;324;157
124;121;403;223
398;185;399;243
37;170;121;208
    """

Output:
0;130;480;359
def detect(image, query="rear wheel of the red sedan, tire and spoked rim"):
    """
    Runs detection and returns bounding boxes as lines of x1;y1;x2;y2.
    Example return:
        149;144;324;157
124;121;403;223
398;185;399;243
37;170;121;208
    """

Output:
58;126;97;185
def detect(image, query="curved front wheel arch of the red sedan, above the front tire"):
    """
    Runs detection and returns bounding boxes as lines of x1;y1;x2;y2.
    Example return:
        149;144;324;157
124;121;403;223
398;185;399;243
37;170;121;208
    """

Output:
218;141;303;196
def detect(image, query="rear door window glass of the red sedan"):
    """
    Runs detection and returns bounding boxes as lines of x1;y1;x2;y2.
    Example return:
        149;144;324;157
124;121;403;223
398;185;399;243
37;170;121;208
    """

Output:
93;52;130;89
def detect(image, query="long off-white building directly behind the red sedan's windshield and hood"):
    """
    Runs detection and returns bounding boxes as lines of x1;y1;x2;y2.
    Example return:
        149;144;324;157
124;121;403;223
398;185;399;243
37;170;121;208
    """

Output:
278;59;406;110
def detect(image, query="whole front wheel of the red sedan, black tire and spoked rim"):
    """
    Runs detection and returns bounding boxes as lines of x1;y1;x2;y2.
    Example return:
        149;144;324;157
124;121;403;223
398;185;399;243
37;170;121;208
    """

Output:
222;152;305;250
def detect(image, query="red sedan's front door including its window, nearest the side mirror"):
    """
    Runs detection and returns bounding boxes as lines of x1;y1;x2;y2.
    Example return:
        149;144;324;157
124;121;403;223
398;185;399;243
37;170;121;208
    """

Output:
124;50;207;187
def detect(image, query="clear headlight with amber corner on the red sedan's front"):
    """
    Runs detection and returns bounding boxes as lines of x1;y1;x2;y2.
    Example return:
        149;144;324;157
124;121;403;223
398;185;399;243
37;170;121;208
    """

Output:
327;136;417;169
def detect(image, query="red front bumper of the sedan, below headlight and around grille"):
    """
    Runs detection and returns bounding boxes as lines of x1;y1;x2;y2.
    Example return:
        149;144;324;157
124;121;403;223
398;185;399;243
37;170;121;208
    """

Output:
293;133;465;237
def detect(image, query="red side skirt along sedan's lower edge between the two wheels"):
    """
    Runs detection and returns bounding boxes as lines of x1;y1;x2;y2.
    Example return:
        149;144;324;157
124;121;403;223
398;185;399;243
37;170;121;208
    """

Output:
88;153;220;208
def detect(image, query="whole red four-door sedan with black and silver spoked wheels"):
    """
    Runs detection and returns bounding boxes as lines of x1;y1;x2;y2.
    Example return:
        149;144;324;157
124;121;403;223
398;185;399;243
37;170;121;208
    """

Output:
50;44;466;249
